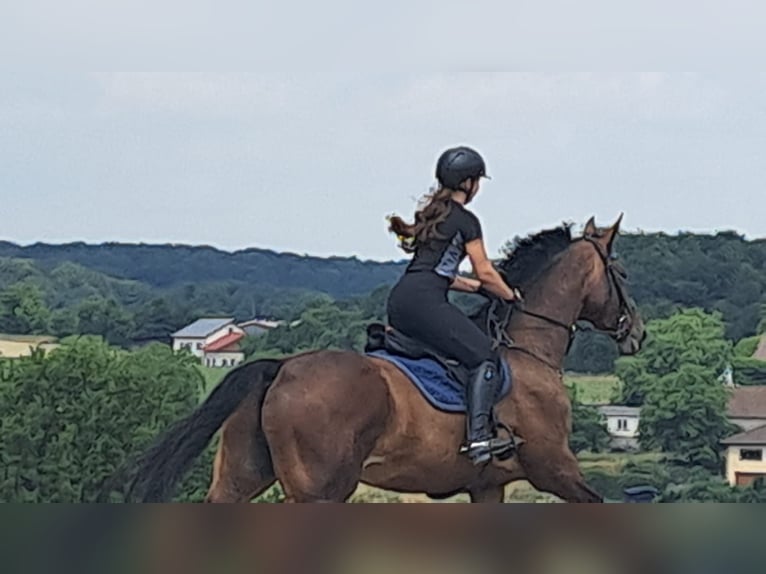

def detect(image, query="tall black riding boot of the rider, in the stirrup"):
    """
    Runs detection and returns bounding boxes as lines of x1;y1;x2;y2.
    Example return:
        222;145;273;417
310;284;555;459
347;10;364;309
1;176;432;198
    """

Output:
460;361;514;466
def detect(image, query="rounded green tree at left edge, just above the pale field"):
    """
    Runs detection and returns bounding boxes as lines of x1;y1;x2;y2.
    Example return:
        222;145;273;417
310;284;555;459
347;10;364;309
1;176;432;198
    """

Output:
0;282;51;335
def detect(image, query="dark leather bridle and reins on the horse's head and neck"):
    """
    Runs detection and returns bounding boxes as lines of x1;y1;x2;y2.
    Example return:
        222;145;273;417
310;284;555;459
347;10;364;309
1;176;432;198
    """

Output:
488;235;636;371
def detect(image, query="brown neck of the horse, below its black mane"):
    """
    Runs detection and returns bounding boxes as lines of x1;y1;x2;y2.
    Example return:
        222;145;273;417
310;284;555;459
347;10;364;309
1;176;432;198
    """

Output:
509;269;583;366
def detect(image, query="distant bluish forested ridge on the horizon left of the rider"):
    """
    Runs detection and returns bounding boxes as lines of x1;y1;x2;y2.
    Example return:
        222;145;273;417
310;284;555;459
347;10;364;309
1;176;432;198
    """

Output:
0;242;402;298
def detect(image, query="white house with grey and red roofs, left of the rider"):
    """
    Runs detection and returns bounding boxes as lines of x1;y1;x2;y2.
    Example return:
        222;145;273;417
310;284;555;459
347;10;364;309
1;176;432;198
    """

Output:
171;317;245;367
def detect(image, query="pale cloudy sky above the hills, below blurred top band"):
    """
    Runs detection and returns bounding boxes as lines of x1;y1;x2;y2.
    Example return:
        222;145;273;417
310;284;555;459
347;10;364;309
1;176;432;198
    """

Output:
0;71;766;260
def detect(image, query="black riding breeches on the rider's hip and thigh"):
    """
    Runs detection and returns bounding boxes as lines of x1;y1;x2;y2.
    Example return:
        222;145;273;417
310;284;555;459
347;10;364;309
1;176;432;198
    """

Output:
388;272;494;369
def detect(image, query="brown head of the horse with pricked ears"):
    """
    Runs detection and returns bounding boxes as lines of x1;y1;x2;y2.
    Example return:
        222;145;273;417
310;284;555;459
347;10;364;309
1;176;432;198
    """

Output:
576;216;646;355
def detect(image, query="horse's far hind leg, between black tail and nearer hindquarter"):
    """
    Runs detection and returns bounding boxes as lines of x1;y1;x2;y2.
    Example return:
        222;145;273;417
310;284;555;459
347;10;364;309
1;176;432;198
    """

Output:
205;404;275;503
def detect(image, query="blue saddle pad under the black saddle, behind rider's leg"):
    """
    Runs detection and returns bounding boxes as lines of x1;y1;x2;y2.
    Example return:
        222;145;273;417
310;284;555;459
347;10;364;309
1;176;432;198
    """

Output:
367;351;511;413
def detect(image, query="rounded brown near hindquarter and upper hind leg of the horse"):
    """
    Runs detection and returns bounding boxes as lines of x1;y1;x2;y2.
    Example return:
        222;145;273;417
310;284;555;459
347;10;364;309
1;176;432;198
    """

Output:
262;352;396;502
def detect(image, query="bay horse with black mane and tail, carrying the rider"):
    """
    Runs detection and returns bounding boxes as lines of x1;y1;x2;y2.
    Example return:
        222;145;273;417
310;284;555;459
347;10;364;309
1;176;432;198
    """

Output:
128;216;645;502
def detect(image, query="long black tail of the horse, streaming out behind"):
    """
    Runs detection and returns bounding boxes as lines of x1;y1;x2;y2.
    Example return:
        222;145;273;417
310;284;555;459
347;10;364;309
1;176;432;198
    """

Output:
127;359;282;502
